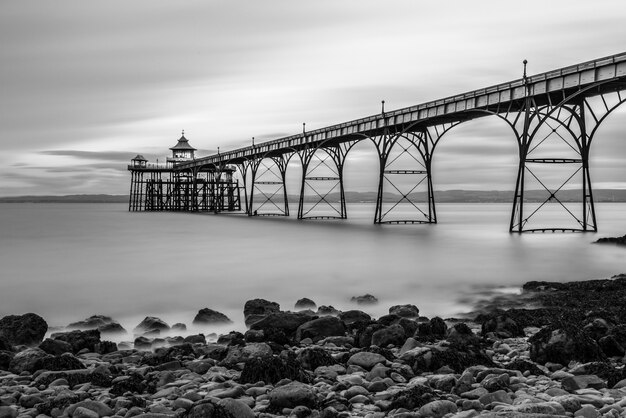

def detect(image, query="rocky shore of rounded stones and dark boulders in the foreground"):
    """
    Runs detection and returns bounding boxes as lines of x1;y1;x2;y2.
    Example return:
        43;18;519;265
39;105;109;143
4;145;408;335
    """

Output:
0;275;626;418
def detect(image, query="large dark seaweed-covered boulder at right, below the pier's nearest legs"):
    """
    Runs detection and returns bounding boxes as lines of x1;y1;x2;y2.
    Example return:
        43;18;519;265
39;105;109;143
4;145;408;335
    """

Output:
528;325;605;364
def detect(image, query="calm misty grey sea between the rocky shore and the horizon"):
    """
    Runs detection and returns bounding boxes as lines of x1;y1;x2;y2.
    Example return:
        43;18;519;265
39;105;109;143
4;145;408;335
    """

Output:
0;204;626;342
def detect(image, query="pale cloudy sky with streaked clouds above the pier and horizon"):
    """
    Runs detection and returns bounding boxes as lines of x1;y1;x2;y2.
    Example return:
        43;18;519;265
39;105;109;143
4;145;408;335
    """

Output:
0;0;626;196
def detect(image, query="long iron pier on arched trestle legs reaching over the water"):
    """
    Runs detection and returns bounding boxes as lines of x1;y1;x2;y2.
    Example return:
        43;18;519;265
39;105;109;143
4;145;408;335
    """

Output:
129;53;626;233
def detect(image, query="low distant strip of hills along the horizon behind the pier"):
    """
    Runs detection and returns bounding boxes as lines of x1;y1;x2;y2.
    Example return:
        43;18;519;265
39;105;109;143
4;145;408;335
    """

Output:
0;189;626;203
